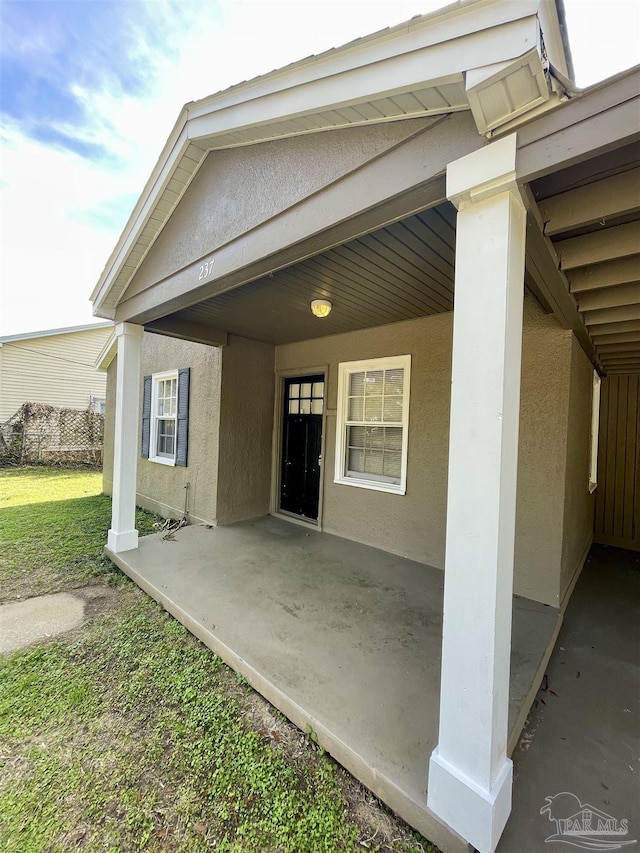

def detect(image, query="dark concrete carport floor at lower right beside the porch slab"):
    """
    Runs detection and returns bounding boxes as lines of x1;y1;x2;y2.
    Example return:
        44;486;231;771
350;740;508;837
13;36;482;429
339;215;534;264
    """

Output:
497;545;640;853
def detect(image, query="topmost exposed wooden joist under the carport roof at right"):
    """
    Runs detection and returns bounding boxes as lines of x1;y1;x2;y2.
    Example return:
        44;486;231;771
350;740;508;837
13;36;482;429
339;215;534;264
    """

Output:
538;168;640;237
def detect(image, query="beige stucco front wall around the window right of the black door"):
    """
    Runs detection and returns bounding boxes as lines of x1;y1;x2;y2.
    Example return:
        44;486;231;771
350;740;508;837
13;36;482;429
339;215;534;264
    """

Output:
276;298;571;605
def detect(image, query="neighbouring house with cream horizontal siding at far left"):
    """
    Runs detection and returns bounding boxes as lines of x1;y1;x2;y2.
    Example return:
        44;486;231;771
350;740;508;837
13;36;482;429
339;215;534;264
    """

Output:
0;323;113;423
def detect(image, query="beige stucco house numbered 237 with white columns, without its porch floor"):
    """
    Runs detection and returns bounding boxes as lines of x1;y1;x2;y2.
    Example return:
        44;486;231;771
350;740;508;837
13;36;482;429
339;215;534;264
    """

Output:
93;0;640;853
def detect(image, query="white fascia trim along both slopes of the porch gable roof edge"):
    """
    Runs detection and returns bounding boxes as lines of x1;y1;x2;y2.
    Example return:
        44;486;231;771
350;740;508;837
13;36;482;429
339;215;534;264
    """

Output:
91;0;540;315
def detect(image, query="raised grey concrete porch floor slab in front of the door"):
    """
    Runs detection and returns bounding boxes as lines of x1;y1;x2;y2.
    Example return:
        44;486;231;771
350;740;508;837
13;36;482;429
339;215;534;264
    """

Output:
107;517;561;851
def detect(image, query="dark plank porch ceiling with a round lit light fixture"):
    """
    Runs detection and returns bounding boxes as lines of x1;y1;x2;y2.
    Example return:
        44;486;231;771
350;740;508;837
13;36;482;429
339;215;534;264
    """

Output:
160;203;455;344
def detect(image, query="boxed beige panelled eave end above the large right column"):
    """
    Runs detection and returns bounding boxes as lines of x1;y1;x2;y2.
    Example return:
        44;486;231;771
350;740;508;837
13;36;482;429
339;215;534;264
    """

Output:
466;48;549;133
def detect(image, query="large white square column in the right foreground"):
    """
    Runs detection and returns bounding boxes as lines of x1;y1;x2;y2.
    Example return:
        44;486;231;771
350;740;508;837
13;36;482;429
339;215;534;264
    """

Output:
428;134;526;853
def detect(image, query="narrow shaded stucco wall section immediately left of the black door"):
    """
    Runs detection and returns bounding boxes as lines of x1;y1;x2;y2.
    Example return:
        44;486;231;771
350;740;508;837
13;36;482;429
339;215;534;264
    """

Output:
217;335;275;524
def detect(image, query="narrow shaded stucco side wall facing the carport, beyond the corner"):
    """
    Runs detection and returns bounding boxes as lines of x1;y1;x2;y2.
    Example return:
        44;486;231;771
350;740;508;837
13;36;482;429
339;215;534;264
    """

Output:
560;338;595;603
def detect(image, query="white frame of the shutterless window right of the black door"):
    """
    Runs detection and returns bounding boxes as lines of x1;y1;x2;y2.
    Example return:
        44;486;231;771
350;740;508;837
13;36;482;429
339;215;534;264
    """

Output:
334;355;411;495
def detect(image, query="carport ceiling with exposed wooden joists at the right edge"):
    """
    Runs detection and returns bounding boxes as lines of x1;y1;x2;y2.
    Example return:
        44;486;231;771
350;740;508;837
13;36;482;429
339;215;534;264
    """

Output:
531;145;640;374
